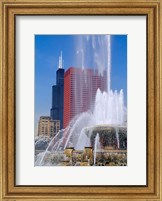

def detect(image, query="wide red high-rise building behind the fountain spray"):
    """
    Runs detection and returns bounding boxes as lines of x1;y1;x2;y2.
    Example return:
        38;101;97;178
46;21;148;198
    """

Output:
64;67;107;128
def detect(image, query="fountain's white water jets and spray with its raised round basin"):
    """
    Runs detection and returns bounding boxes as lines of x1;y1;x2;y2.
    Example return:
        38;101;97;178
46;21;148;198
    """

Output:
36;35;127;165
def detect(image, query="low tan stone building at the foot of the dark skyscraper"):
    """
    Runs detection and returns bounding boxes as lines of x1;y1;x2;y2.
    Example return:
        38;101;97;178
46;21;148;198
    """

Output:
38;116;60;137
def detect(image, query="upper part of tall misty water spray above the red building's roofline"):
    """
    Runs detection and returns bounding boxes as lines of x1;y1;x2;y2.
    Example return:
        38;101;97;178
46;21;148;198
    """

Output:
76;35;111;77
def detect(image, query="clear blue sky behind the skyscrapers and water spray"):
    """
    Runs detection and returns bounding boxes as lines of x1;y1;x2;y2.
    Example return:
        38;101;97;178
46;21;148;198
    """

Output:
35;35;127;132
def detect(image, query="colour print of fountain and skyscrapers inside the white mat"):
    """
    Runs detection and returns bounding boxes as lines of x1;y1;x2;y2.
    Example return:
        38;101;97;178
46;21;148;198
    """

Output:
35;33;127;166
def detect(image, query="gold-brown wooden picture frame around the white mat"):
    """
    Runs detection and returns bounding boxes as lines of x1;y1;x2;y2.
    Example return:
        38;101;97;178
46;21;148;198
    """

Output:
0;0;162;201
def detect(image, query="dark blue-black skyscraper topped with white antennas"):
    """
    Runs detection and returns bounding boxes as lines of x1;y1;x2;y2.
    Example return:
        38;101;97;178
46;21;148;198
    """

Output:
51;53;64;129
